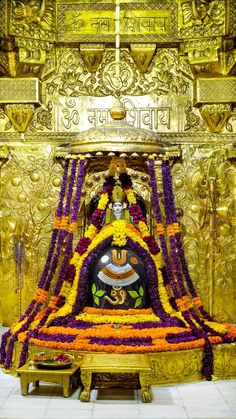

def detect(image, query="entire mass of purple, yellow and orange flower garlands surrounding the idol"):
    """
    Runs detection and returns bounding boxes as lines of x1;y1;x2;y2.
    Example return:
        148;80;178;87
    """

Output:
1;156;236;380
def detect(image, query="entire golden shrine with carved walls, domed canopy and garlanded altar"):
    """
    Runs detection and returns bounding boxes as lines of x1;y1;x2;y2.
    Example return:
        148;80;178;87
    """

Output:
0;0;236;383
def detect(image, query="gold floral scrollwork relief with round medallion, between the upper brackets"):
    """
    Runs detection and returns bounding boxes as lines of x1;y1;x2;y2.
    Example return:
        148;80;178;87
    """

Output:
47;49;189;97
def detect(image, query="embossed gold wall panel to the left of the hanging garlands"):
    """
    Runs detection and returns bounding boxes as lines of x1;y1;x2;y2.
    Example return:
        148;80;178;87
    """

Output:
0;146;62;324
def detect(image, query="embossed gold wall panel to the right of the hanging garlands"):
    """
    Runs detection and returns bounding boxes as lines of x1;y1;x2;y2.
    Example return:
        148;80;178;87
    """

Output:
172;146;236;322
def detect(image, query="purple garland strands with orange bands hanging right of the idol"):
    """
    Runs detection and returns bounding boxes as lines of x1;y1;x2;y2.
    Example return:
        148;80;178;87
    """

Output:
148;158;236;380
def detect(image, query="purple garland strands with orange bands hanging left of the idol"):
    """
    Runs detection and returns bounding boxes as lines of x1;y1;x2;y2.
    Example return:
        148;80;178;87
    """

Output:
0;156;85;370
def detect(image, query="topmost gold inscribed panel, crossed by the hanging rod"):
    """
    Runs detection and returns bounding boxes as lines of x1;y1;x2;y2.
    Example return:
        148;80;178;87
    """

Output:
57;0;178;42
